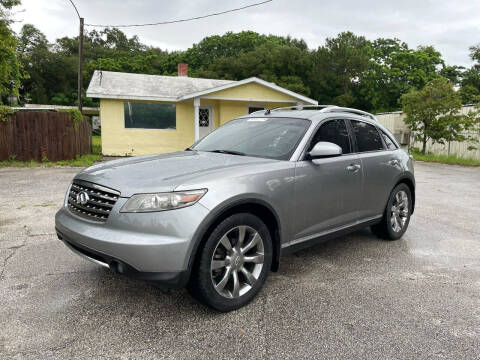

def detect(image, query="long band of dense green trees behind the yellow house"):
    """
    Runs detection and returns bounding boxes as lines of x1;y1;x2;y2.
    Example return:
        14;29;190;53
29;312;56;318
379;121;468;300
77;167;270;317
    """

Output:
6;22;480;116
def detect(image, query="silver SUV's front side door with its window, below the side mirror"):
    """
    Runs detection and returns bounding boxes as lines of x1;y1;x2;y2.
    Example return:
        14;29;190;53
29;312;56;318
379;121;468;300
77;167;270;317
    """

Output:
294;119;362;241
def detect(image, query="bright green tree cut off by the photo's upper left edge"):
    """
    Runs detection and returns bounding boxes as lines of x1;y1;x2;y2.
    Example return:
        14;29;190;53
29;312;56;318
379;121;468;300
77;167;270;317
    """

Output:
0;0;20;104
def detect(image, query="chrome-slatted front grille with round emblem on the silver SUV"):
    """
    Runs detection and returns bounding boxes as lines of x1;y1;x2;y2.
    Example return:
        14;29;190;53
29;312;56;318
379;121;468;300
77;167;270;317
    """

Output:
68;180;120;222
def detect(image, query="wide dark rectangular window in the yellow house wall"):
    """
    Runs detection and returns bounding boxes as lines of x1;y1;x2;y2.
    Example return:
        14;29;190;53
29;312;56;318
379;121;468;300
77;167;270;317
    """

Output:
123;102;176;129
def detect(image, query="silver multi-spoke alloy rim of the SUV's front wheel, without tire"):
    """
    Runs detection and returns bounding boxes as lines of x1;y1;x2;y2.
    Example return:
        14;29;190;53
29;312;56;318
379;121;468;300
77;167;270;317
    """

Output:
210;225;264;298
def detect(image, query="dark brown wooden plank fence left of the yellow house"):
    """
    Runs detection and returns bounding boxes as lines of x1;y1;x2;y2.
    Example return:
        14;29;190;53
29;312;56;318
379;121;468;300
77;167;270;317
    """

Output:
0;111;92;161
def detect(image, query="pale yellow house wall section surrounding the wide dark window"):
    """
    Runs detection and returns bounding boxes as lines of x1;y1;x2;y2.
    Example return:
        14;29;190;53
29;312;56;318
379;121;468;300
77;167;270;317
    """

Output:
100;99;194;156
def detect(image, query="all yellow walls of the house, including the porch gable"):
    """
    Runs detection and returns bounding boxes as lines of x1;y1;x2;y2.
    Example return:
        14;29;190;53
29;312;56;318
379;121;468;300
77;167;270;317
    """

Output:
100;83;308;156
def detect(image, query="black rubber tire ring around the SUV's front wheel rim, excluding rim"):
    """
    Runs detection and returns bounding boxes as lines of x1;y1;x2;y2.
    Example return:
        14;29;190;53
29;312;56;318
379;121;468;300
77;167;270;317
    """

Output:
191;213;273;311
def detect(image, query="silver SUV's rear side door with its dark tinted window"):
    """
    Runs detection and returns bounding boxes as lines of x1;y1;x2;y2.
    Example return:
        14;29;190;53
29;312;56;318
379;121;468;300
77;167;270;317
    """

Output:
349;119;402;221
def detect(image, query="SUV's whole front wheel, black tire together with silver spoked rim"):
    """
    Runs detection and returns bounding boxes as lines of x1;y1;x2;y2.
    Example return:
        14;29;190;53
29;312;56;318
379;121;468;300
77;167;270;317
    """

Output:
188;213;272;312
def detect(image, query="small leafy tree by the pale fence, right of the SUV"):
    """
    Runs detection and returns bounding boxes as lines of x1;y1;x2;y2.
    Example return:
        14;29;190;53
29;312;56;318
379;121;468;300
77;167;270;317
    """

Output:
400;78;475;153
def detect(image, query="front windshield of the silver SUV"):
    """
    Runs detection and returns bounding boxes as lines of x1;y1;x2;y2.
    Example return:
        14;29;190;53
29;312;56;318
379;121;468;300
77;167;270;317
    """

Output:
192;117;310;160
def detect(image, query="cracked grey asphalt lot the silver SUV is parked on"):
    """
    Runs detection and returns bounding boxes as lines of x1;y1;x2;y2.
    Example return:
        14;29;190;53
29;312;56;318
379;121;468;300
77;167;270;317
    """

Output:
0;163;480;359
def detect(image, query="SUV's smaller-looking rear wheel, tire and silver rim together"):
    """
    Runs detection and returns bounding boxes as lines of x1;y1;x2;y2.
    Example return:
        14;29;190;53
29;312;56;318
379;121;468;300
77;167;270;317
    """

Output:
371;183;412;240
